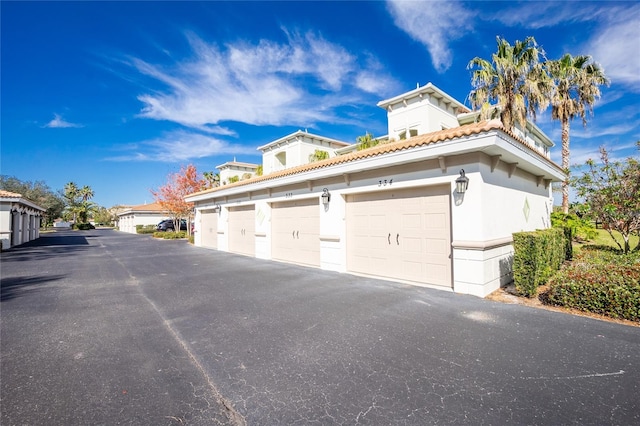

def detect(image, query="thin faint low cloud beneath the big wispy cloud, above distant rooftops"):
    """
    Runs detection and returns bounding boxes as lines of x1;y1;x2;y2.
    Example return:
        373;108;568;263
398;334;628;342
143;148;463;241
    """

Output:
106;130;256;163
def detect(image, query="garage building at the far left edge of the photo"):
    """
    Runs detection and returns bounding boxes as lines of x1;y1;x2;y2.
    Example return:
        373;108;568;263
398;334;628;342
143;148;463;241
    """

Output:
0;190;46;250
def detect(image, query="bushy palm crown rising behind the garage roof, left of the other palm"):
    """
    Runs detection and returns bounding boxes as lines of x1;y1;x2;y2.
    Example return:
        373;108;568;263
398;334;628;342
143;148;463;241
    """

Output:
467;37;551;130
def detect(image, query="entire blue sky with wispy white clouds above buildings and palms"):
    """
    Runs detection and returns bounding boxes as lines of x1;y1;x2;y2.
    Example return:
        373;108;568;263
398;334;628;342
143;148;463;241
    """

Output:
0;1;640;207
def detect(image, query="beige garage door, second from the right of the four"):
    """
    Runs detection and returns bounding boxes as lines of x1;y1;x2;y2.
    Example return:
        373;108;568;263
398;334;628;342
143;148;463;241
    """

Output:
271;198;320;266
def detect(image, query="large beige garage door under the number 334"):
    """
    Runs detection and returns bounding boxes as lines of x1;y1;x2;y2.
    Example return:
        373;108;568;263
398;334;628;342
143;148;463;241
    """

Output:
347;186;452;287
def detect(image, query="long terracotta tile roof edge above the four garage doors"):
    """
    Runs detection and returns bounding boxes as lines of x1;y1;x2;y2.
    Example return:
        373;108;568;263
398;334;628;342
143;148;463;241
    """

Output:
189;119;549;197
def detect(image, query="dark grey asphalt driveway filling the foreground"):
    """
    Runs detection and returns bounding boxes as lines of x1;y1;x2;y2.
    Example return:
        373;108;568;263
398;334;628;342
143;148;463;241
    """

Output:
0;230;640;425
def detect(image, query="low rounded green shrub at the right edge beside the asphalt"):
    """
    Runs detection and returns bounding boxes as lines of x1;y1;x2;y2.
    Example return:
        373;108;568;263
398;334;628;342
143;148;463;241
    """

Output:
548;249;640;321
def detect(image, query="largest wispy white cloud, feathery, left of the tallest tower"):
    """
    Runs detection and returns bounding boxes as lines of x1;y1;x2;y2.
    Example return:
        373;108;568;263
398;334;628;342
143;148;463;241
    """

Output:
129;31;395;135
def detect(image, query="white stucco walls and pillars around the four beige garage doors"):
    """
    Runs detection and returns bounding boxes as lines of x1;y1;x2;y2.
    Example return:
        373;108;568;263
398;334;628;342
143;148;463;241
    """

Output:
191;128;552;297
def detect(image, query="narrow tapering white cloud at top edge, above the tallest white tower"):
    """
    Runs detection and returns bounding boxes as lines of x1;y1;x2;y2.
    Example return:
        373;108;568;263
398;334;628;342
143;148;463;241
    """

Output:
387;0;474;73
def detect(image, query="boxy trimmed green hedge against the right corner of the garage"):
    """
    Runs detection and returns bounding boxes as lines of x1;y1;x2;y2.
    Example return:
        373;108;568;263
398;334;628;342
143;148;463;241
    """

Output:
513;228;571;297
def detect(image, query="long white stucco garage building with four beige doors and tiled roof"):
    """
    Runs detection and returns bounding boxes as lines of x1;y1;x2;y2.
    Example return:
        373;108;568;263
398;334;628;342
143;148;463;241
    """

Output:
186;84;564;297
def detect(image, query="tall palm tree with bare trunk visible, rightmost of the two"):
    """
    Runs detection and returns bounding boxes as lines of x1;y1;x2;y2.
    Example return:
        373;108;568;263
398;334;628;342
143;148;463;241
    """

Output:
546;53;609;214
